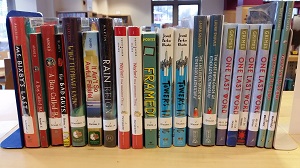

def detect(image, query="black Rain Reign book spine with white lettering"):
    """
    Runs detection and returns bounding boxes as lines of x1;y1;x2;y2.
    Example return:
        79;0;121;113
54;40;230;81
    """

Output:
99;18;117;147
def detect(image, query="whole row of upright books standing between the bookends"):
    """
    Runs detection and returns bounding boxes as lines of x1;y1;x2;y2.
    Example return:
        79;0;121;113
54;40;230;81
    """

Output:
10;2;293;149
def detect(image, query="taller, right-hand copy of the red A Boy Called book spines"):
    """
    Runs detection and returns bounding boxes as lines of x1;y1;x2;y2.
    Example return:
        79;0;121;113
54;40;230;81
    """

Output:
41;25;63;145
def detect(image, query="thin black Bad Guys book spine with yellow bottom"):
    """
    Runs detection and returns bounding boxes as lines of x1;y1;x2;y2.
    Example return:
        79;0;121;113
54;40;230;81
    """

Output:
55;34;71;146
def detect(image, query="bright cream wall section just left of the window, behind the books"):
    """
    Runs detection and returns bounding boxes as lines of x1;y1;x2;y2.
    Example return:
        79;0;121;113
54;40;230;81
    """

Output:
107;0;151;26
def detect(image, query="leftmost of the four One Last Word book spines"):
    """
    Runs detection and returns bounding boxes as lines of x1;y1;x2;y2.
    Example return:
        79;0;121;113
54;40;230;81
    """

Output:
216;24;237;145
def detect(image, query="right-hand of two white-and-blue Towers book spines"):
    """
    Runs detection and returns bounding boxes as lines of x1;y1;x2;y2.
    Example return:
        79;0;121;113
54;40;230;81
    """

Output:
173;28;190;146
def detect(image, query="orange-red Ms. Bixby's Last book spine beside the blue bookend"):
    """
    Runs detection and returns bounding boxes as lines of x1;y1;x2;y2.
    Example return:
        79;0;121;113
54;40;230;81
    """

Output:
10;17;40;147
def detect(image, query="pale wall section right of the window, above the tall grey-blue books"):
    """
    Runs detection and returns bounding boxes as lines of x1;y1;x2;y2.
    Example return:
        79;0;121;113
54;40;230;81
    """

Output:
201;0;224;15
